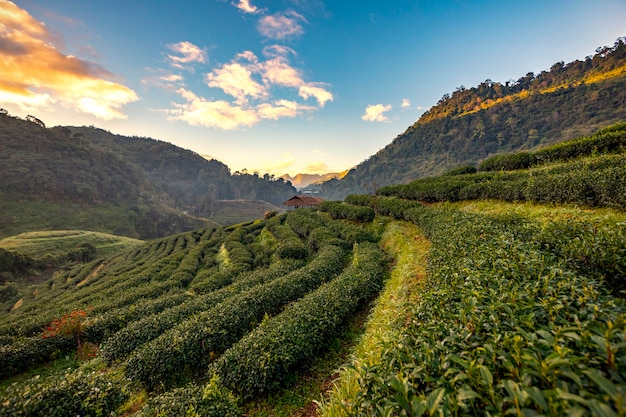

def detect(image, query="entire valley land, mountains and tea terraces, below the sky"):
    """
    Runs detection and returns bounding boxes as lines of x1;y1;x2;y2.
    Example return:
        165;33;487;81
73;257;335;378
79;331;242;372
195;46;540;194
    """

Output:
0;39;626;417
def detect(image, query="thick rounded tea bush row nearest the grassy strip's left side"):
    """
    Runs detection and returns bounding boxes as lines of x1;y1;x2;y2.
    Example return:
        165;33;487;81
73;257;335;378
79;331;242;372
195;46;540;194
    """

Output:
210;243;386;397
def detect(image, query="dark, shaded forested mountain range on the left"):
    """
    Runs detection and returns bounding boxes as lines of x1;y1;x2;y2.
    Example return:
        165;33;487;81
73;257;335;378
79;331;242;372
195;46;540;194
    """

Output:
0;117;296;239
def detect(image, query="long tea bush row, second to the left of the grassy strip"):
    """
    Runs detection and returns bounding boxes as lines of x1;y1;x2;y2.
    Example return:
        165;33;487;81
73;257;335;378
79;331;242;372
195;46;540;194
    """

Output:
124;246;345;390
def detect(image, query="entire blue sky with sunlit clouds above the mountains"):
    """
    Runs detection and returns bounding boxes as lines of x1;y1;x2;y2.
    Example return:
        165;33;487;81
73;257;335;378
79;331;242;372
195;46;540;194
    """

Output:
0;0;626;176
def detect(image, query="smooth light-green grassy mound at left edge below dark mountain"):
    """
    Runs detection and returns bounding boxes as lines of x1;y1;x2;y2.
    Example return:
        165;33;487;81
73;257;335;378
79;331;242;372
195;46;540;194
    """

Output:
0;230;143;258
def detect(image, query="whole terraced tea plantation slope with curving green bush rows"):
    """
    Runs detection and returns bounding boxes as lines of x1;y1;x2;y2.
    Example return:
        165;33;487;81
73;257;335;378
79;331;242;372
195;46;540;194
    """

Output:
0;125;626;416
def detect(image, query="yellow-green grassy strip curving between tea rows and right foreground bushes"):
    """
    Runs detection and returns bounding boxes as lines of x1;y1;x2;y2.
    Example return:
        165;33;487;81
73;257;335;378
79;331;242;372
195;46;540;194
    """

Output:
319;221;430;417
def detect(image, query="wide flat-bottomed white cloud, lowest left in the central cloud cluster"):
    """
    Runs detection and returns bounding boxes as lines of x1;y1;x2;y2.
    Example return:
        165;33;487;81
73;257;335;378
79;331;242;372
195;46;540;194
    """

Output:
166;89;259;130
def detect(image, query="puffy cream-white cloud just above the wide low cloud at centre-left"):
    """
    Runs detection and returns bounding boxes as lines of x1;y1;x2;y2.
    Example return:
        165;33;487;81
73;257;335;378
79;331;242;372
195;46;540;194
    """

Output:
206;62;267;102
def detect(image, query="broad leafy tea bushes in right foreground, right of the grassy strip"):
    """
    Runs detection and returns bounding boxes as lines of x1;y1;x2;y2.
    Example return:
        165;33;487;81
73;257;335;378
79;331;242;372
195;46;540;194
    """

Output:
344;201;626;416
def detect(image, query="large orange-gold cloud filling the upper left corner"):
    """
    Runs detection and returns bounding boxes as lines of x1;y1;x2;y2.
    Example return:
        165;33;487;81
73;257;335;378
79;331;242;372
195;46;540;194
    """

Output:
0;0;138;120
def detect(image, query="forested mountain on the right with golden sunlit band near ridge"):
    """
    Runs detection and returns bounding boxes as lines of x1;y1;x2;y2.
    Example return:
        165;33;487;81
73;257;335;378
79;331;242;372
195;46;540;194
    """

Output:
307;38;626;199
